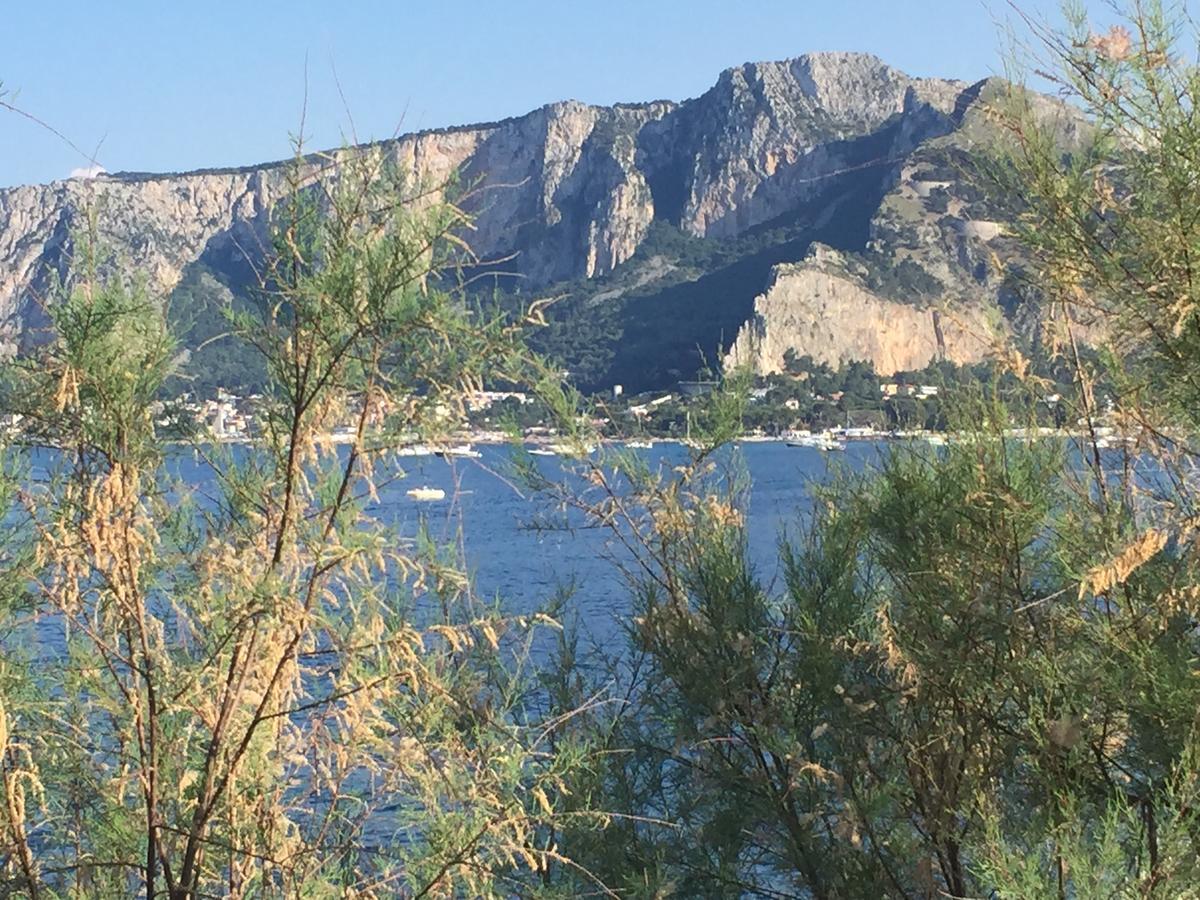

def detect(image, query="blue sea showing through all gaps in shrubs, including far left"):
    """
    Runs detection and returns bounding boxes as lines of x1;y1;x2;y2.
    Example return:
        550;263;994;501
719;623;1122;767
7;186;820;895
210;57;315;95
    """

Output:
16;440;888;656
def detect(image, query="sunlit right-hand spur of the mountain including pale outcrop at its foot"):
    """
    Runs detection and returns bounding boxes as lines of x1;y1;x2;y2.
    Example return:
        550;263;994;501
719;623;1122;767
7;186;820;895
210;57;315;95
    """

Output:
726;82;1085;374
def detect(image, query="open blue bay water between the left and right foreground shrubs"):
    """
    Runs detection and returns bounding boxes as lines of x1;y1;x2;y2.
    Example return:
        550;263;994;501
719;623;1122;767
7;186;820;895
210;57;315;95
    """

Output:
350;442;882;636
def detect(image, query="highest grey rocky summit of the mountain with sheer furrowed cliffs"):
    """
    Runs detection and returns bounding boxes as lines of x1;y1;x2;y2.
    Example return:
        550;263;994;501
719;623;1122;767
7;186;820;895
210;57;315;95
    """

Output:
648;53;966;238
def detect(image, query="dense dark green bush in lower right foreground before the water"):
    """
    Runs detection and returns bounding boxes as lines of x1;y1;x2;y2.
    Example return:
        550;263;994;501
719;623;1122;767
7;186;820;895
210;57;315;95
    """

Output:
542;400;1200;896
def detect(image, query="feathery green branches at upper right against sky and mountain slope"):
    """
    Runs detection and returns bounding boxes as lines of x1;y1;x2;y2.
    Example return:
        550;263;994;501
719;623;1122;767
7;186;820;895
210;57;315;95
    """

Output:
991;0;1200;427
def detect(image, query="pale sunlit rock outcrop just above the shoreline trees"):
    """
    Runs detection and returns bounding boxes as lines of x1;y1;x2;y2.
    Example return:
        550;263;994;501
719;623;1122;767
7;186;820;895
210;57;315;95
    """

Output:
725;247;1004;374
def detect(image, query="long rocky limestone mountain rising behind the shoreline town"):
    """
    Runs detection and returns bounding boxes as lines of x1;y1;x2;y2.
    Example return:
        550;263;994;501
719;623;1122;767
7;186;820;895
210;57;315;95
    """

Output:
0;53;1080;389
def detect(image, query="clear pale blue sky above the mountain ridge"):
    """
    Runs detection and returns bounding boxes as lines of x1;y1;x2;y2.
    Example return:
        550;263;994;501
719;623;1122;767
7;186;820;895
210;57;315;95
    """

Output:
0;0;1113;185
